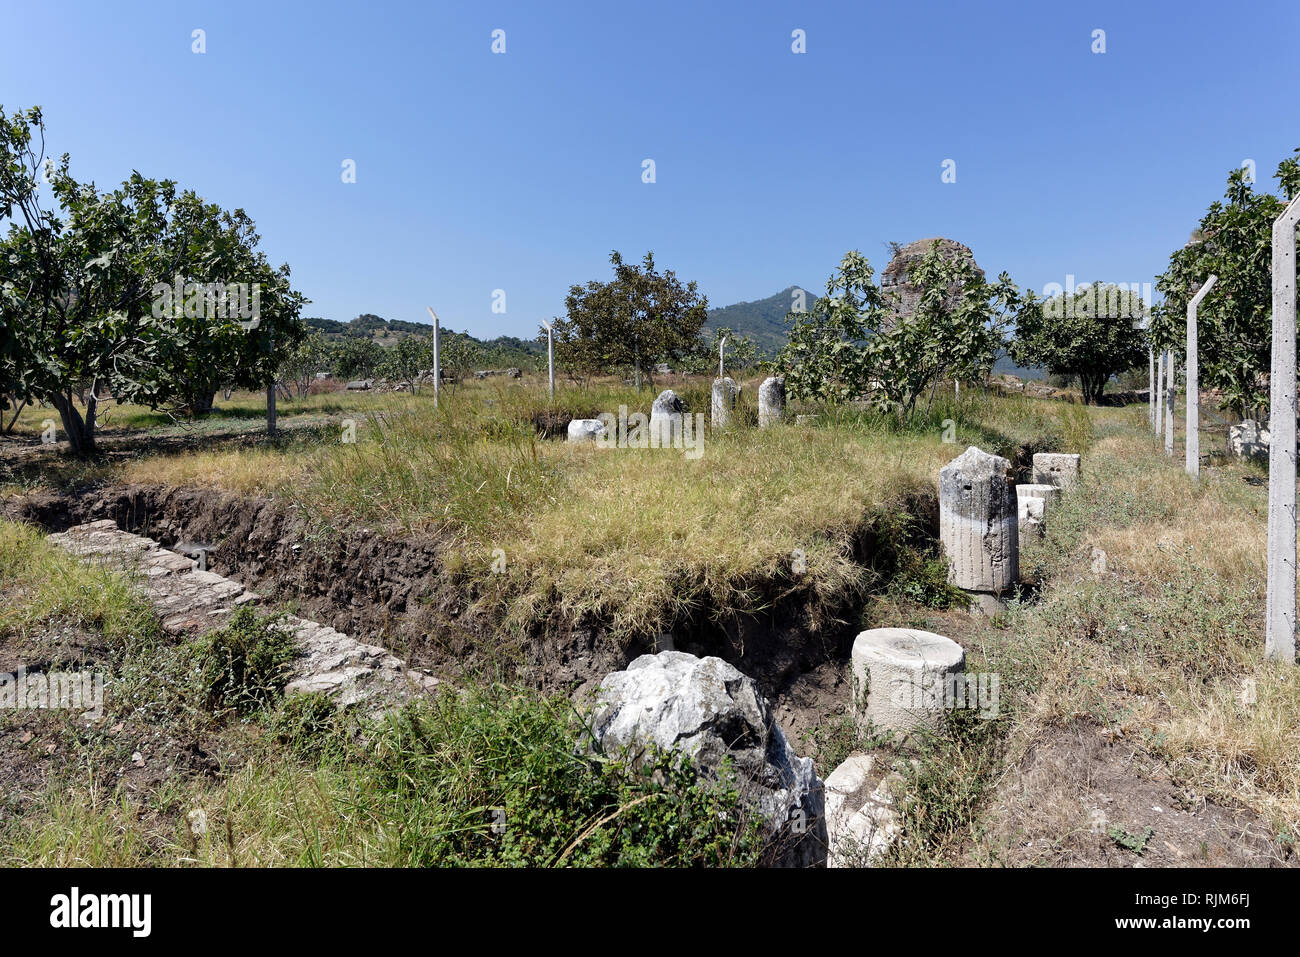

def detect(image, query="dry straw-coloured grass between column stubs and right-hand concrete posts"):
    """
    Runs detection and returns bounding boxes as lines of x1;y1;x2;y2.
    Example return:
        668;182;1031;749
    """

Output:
987;416;1300;835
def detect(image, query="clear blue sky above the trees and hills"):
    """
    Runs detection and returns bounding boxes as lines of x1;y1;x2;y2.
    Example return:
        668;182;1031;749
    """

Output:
0;0;1300;335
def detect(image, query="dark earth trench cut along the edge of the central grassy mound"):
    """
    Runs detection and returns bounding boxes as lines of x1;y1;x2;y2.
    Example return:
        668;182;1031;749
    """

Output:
4;485;956;712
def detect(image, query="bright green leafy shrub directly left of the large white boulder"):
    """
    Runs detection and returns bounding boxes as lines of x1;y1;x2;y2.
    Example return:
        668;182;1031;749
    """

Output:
364;685;762;867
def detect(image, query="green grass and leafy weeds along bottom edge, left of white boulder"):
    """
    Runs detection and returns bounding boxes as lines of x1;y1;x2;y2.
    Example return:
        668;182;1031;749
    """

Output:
0;687;762;867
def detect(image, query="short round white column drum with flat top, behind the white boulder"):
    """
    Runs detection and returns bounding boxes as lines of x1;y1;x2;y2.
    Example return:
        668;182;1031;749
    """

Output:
850;628;966;733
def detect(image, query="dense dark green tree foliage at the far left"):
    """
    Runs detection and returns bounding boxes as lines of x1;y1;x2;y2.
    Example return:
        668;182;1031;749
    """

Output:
0;108;306;454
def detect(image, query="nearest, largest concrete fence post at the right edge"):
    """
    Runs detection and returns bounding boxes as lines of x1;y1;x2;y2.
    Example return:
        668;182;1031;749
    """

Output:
1264;196;1300;664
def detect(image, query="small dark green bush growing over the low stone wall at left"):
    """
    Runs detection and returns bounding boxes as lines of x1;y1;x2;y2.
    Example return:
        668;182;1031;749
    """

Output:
199;606;295;714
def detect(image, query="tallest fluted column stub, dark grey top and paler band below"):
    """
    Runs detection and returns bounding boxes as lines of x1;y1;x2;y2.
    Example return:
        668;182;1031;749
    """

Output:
939;446;1021;609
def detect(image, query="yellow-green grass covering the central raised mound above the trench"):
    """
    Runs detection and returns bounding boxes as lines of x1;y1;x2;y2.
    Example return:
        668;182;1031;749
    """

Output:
0;378;1088;640
